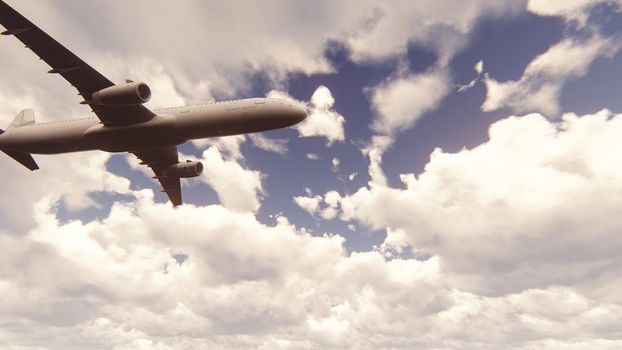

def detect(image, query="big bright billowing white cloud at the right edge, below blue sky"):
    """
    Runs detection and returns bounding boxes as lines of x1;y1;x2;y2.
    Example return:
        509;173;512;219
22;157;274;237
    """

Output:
324;111;622;295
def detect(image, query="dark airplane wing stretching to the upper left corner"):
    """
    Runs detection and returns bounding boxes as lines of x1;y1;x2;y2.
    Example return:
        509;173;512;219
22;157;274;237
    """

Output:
0;0;154;125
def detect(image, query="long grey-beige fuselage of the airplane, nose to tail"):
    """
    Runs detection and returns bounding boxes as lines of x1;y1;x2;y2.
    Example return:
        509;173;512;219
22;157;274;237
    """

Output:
0;98;306;154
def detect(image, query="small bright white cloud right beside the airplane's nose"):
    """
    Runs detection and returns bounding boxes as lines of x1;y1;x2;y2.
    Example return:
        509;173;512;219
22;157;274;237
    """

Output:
268;85;346;146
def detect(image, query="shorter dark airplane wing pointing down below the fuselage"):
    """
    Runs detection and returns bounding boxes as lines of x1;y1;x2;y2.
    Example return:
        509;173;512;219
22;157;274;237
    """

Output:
132;146;182;206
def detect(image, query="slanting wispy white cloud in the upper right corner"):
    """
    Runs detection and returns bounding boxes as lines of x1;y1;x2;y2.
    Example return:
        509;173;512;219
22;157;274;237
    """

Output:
482;0;622;117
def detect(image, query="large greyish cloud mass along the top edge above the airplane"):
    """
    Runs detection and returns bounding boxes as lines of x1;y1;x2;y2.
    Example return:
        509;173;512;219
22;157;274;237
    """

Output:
0;0;523;102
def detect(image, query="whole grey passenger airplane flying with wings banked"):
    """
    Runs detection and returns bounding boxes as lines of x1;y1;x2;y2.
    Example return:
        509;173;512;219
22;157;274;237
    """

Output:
0;0;307;206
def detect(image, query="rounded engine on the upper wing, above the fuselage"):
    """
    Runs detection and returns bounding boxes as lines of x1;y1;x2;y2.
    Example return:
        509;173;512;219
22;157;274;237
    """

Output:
92;82;151;106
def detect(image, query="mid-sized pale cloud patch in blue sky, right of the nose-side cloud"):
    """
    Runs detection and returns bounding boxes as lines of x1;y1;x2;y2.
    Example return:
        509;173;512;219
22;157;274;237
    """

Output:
369;69;451;135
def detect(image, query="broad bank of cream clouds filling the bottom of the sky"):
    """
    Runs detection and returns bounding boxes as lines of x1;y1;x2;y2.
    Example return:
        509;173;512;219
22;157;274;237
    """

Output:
0;190;622;350
